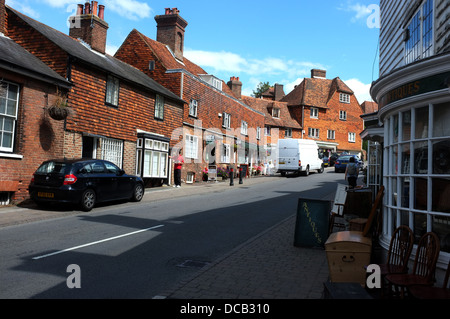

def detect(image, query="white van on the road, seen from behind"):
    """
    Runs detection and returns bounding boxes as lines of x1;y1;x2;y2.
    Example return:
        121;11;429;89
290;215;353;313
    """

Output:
278;139;324;176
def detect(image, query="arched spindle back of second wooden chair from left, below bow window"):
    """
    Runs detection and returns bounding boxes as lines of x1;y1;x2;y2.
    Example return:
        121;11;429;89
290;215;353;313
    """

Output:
412;232;440;282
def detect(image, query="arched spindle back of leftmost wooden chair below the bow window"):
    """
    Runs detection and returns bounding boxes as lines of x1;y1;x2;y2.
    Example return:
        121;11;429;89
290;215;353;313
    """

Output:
387;225;414;272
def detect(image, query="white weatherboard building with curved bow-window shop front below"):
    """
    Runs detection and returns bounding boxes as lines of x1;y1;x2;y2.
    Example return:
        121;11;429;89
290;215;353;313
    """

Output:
371;0;450;281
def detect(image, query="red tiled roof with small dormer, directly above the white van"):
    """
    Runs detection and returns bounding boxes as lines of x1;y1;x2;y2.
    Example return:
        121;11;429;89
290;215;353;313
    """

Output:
242;95;301;129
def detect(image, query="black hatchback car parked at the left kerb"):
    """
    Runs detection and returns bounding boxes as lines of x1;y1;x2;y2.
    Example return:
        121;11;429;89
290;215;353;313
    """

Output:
28;159;145;211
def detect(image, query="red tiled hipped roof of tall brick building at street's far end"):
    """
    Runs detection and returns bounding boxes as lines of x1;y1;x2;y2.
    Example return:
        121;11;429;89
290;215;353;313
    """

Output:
281;77;354;108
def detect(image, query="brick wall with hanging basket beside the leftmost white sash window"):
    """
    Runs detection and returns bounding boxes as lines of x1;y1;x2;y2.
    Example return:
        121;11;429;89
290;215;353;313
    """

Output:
0;70;64;202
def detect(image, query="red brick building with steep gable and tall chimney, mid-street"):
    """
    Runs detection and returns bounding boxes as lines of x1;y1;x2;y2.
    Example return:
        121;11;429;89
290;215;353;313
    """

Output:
115;8;264;182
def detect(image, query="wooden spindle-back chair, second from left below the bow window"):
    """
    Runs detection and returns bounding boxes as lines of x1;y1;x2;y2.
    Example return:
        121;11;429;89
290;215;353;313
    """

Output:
386;232;440;299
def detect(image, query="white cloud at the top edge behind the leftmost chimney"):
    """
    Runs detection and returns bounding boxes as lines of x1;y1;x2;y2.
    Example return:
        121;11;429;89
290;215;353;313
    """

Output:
42;0;152;20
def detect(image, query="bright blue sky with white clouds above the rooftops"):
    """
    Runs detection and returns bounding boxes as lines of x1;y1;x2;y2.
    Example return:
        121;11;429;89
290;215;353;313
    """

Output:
6;0;379;103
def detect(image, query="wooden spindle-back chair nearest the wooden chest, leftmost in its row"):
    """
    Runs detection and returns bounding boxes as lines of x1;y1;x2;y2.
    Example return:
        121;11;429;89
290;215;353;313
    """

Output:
378;225;414;297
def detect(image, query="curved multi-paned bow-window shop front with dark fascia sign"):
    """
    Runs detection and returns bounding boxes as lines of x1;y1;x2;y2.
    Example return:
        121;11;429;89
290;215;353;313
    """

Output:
371;53;450;266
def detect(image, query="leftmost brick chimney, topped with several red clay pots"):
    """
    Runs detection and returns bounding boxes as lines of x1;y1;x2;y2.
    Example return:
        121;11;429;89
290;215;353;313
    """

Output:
69;1;109;54
